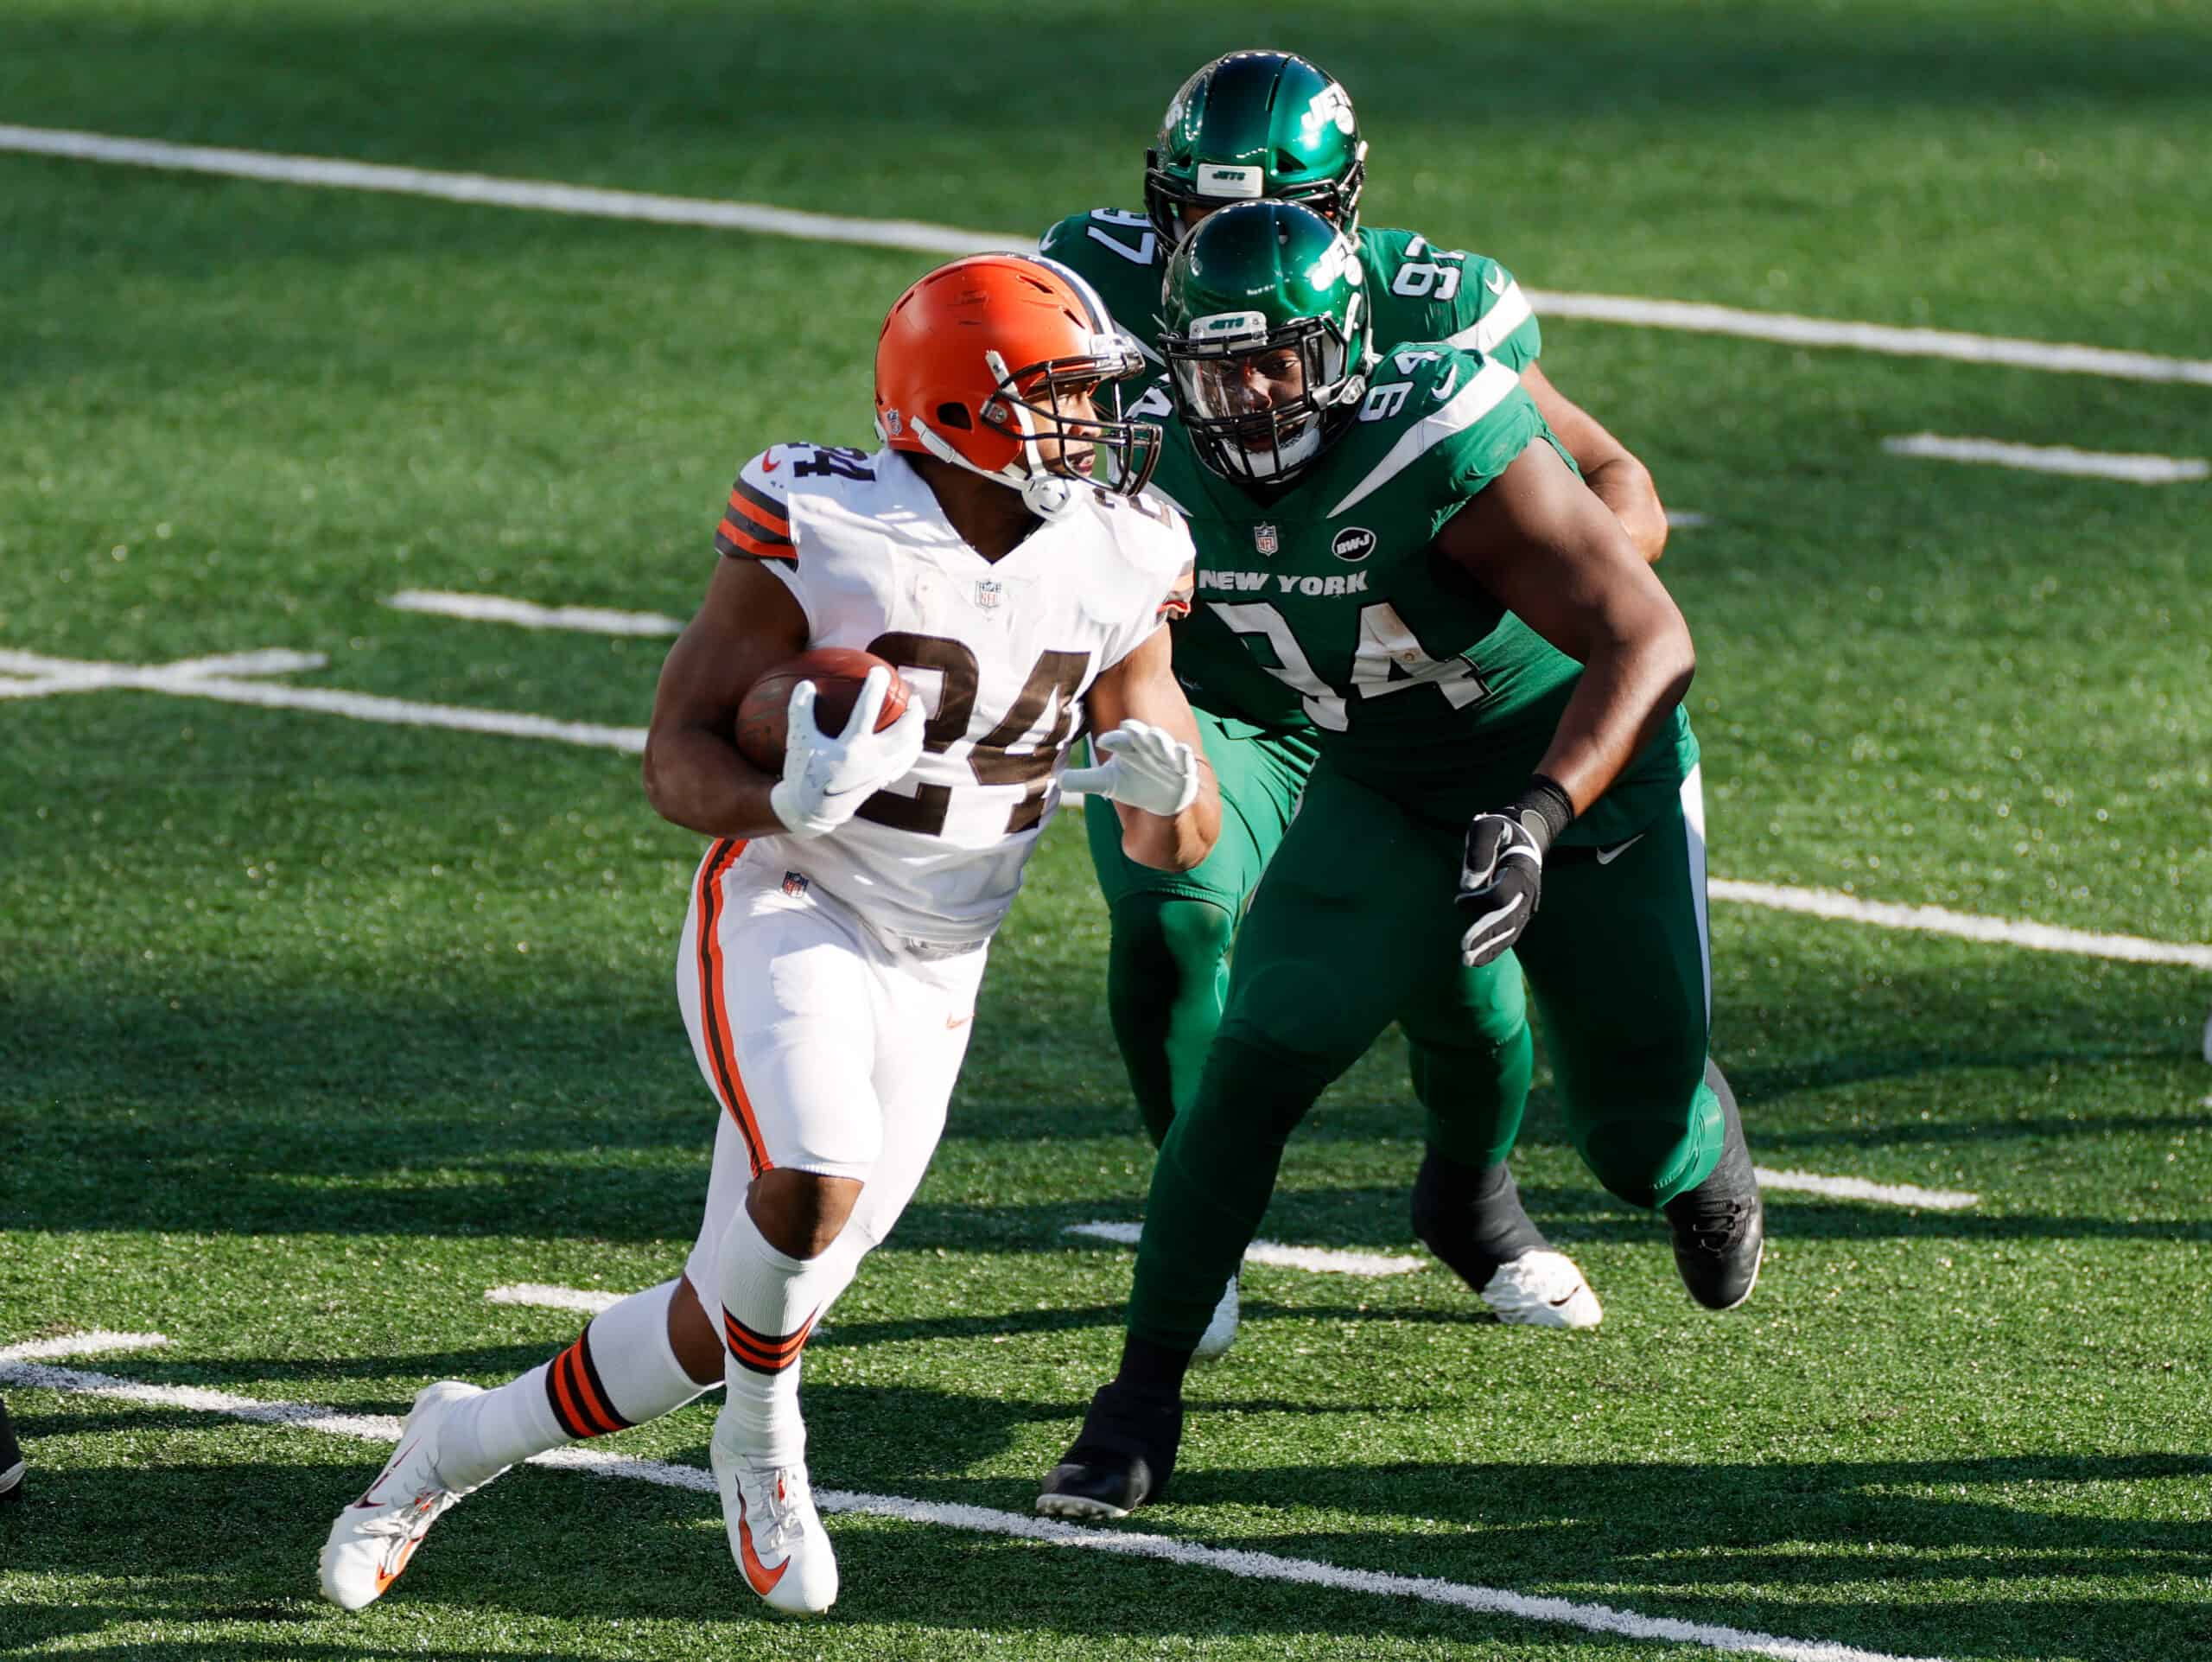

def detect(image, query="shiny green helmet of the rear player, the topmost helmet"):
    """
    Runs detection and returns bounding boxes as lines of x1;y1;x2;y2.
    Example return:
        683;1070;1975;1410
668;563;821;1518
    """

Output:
1144;51;1367;248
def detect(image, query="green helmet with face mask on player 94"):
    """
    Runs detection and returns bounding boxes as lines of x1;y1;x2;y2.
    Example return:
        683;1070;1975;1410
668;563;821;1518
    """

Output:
1159;201;1376;485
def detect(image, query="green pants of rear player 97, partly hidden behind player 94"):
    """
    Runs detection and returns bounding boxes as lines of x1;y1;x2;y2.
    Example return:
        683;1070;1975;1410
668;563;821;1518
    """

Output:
1084;710;1531;1168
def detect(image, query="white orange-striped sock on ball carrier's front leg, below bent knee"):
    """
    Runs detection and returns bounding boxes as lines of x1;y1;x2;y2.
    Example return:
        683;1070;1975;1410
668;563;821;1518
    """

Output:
715;1207;858;1465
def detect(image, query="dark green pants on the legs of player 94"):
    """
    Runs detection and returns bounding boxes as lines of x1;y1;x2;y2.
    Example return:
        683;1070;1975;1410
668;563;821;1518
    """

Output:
1130;763;1723;1350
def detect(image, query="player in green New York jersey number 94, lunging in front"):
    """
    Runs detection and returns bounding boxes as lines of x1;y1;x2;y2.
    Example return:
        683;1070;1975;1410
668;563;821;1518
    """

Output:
1038;201;1763;1519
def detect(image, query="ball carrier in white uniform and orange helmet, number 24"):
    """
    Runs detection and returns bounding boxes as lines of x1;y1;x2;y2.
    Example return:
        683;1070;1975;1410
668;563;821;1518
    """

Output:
321;254;1221;1614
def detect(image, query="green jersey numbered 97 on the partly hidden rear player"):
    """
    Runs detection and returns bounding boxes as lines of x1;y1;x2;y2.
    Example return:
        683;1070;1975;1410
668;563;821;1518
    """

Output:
1038;208;1544;733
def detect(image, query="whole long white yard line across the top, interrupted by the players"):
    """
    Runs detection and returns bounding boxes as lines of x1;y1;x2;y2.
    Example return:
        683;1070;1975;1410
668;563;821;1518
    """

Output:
0;126;2212;387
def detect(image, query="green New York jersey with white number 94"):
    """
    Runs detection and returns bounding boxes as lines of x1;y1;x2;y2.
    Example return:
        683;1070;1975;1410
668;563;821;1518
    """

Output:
1146;341;1697;844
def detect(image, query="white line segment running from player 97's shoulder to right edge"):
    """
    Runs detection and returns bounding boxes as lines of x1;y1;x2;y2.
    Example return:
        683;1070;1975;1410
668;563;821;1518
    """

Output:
1529;290;2212;387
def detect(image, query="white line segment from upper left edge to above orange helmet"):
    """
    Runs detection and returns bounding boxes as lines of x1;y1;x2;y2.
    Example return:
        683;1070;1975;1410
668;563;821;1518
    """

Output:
0;126;995;254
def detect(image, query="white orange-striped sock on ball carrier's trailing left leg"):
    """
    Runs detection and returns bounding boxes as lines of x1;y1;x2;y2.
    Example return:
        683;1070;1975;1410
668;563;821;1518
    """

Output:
438;1282;706;1489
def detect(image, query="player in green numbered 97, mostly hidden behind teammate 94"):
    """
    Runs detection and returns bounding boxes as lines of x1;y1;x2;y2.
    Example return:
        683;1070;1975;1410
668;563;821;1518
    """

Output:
1039;51;1666;1357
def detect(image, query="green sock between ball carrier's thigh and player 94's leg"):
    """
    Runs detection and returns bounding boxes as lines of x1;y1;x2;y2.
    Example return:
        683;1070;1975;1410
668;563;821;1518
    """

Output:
1106;894;1236;1150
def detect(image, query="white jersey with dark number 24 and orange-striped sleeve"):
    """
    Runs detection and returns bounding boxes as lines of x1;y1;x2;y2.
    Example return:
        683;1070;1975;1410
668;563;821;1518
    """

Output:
715;445;1192;945
